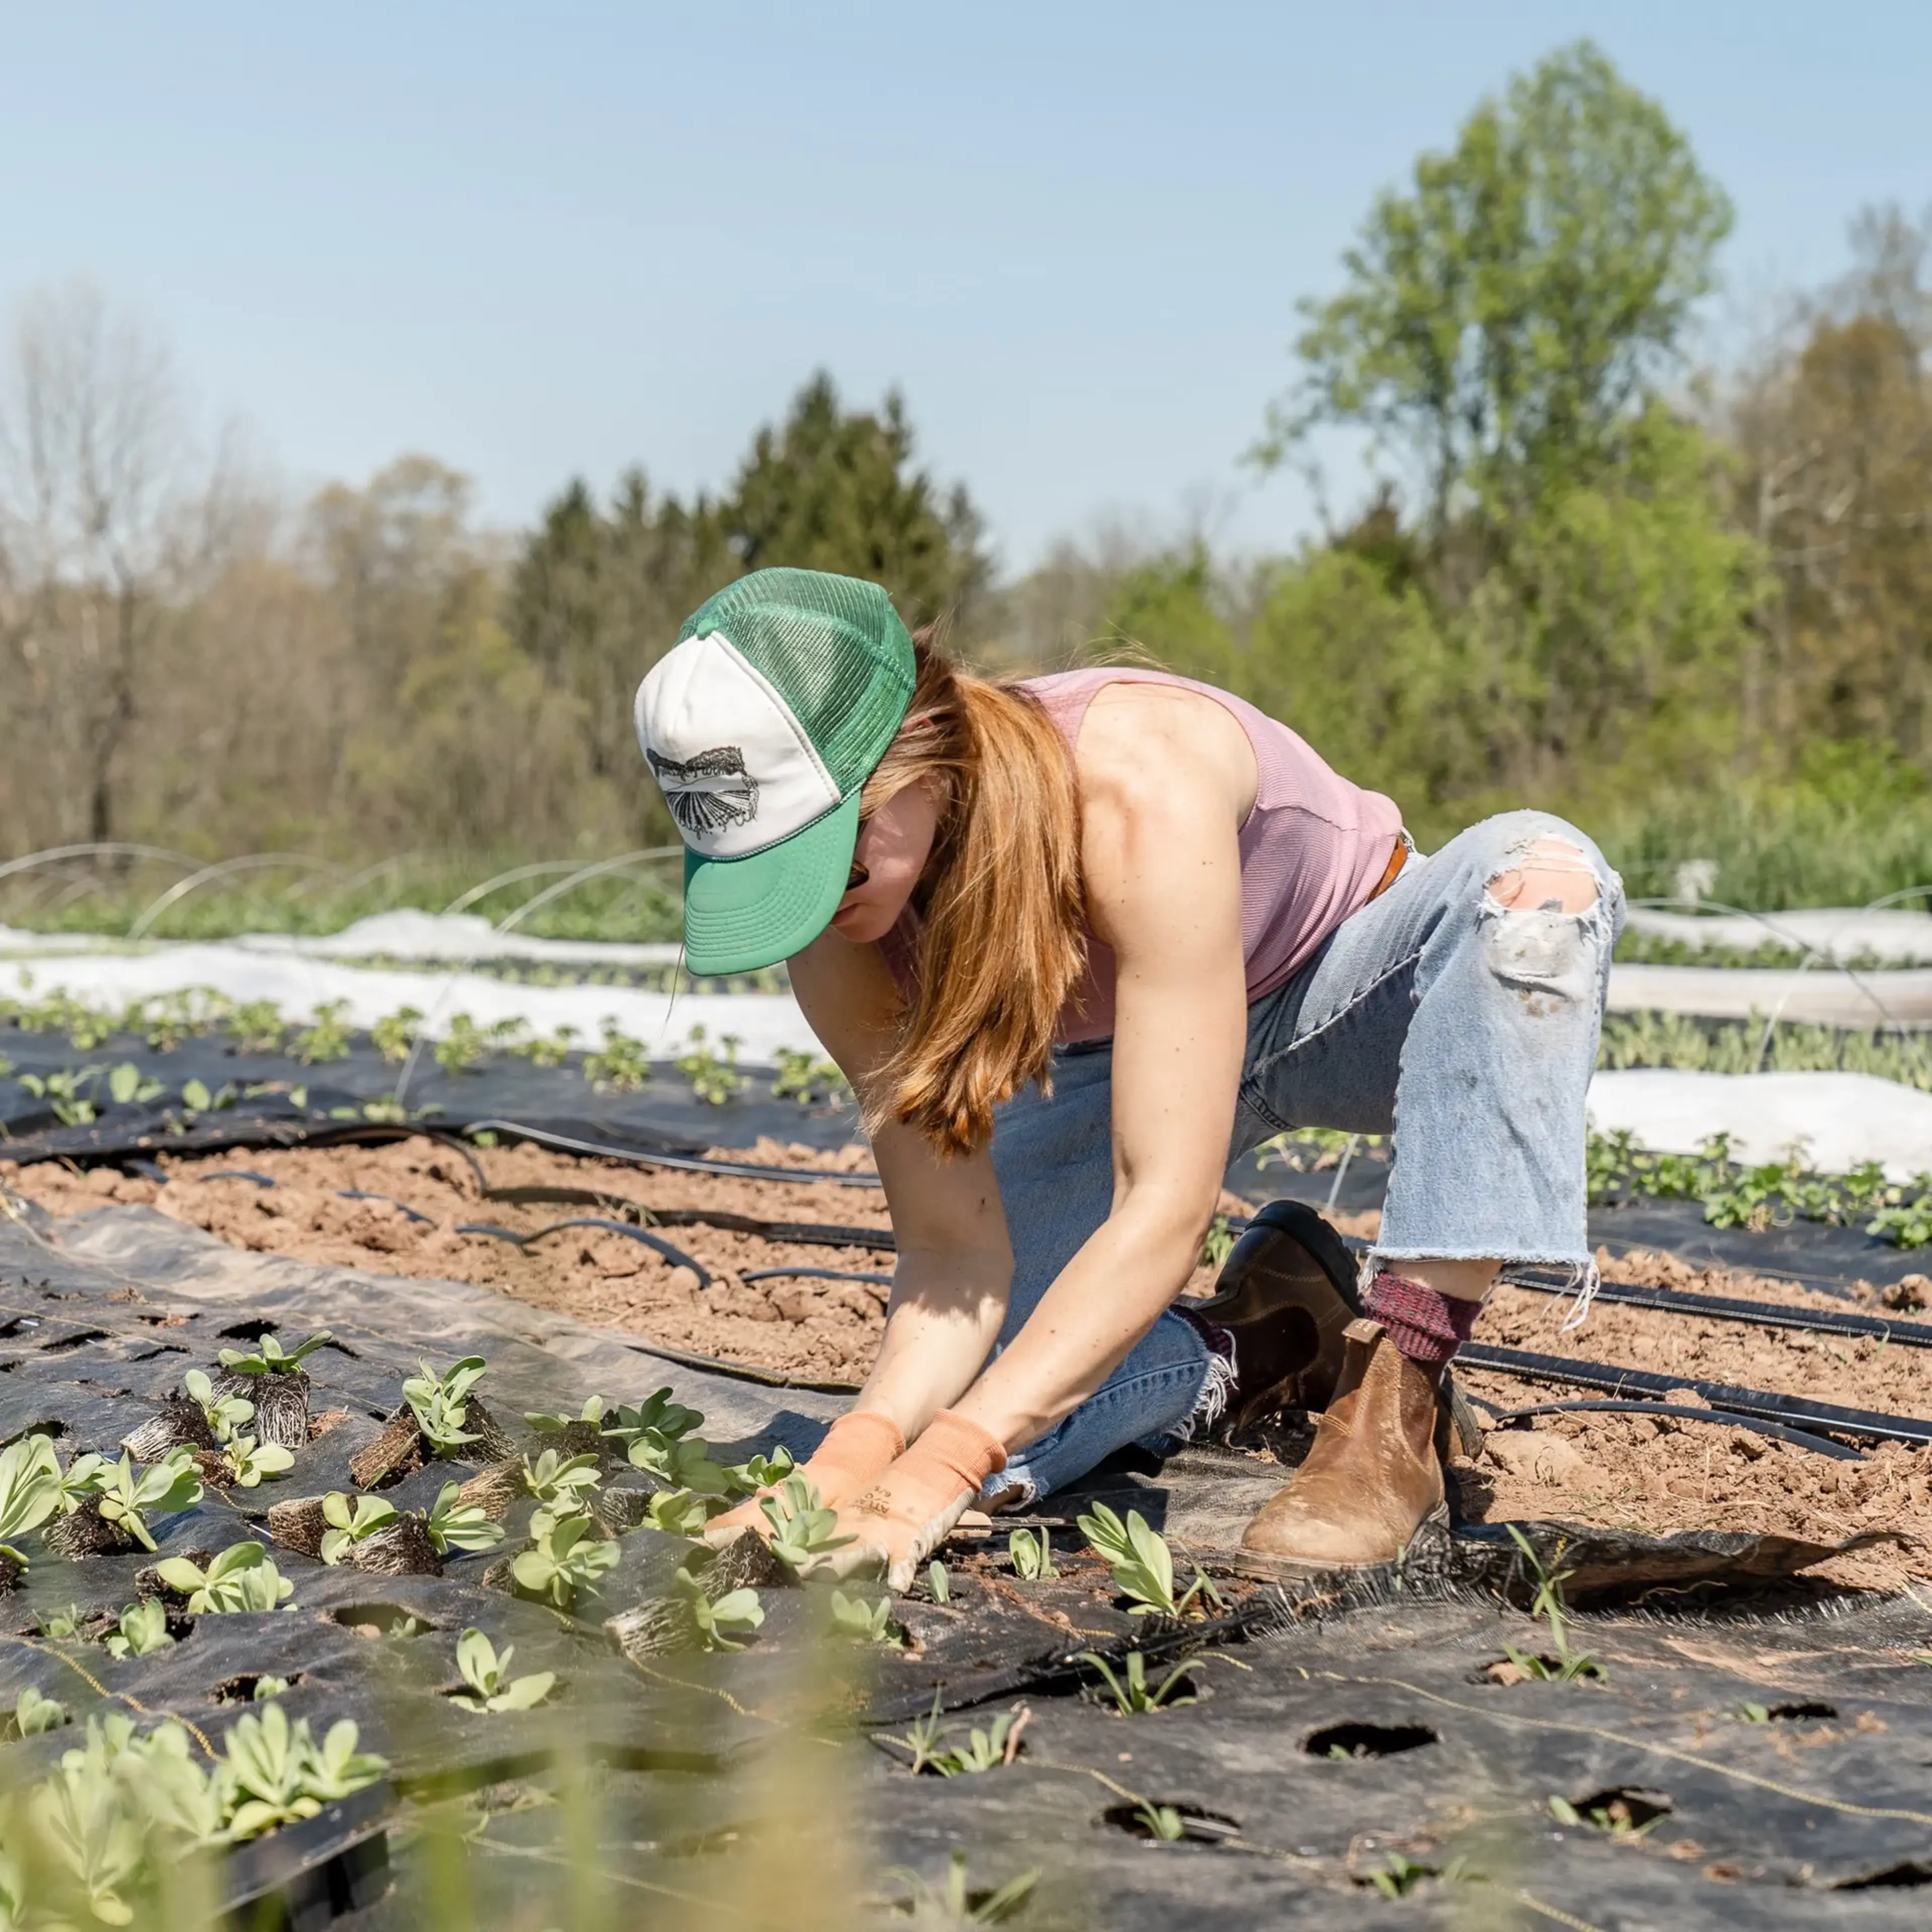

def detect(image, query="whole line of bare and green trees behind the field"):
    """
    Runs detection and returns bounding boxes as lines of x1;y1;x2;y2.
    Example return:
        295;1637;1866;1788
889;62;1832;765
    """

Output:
0;42;1932;902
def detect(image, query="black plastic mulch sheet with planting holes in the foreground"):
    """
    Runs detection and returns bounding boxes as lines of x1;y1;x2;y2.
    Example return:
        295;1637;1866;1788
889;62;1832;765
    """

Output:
0;1208;1932;1932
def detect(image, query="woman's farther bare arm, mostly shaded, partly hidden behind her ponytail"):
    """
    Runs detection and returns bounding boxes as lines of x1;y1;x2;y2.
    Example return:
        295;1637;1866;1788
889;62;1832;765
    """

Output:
790;931;1020;1441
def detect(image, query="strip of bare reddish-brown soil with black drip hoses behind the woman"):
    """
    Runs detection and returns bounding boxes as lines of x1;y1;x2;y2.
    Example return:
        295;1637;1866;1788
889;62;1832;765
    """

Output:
0;1138;1932;1588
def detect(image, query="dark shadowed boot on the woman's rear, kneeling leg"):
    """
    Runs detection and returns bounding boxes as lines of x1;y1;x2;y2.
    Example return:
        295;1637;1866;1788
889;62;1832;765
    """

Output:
1180;1201;1362;1430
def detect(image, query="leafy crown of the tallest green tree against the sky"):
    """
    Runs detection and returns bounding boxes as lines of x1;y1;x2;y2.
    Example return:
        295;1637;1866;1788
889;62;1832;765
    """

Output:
1263;41;1731;541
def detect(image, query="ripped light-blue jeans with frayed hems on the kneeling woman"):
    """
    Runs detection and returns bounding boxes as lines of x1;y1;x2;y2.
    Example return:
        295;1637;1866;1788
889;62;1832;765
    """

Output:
987;812;1623;1507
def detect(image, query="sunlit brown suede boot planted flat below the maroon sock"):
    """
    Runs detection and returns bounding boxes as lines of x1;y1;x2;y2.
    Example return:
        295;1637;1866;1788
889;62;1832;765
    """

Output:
1237;1318;1449;1576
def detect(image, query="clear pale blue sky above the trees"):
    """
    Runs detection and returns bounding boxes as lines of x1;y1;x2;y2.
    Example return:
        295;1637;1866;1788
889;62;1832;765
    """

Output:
0;0;1932;568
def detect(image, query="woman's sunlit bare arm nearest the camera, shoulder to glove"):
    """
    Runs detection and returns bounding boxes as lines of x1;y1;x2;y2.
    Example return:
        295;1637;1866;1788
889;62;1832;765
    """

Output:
954;686;1254;1449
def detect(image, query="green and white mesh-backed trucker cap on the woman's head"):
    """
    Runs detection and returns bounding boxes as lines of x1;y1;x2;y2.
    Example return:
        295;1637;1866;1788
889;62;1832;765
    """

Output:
637;570;914;974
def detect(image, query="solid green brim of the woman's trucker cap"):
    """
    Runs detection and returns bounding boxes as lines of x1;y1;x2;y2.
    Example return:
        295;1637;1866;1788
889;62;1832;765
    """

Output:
684;792;858;978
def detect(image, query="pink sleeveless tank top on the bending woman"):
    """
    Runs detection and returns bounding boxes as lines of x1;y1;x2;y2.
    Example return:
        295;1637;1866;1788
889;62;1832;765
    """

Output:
879;665;1403;1041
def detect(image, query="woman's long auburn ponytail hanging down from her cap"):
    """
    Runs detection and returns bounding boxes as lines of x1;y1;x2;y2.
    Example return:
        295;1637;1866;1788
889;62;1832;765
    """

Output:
862;632;1086;1153
